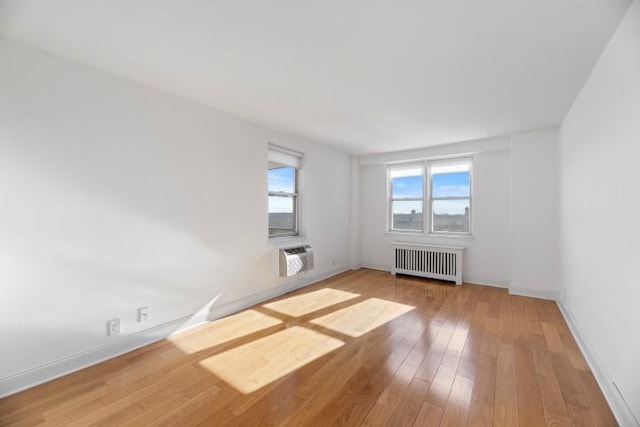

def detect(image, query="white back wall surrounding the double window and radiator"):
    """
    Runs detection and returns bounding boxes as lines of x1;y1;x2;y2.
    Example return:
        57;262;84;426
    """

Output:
359;138;511;287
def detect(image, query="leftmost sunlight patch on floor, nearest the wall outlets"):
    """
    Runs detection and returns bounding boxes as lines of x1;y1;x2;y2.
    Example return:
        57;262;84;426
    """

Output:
168;310;282;354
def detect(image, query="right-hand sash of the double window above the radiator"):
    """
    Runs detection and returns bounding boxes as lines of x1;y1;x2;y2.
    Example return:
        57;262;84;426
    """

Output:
429;159;471;234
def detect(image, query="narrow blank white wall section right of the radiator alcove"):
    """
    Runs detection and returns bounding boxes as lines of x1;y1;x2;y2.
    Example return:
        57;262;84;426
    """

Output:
510;129;560;299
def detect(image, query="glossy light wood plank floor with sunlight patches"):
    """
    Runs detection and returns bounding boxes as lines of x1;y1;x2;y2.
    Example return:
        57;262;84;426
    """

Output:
0;269;616;427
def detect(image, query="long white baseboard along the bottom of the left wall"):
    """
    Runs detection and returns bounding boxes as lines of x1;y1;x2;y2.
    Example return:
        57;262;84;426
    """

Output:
0;267;349;398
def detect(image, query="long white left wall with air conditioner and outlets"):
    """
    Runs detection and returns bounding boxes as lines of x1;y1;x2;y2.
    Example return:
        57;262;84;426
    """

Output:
0;41;350;395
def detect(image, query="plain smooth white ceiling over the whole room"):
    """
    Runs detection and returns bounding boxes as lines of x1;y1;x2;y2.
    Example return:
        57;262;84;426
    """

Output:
0;0;630;154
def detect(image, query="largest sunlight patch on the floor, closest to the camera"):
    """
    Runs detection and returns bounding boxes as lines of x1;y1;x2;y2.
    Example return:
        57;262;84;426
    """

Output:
199;326;344;394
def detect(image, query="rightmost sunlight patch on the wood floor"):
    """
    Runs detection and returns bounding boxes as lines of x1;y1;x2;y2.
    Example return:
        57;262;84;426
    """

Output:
311;298;415;337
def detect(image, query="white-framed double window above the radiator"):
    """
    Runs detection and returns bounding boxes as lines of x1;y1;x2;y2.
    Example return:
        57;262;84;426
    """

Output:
388;158;472;235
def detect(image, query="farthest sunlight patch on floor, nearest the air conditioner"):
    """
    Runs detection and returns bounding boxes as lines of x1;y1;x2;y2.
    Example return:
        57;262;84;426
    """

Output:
263;288;360;317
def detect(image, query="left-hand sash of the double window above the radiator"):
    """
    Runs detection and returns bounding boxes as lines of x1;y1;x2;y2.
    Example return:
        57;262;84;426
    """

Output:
389;165;424;232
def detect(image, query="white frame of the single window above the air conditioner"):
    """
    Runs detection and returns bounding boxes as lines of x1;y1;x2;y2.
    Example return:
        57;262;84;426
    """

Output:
267;144;303;240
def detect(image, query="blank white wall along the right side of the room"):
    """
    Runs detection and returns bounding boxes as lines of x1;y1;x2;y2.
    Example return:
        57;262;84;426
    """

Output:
560;0;640;425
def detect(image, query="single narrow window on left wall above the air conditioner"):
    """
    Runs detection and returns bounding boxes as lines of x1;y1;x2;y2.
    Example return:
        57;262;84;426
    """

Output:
267;145;302;238
